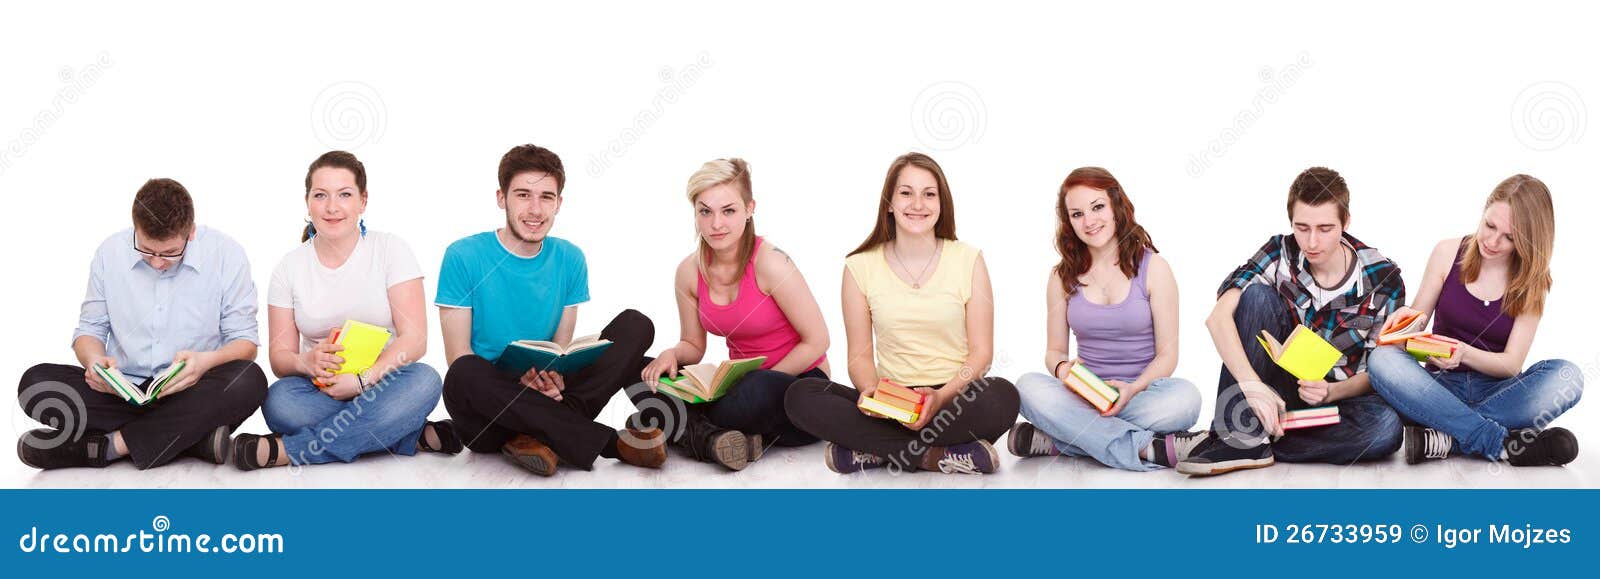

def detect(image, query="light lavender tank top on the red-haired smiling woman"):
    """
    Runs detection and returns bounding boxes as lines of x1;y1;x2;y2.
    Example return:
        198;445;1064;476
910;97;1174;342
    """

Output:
1067;250;1155;382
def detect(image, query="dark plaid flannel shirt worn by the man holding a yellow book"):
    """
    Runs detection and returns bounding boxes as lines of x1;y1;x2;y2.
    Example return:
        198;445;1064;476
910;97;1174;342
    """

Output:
1216;234;1405;381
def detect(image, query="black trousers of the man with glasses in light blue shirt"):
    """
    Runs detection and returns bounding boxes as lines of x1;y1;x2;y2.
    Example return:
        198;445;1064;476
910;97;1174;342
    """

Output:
16;360;267;469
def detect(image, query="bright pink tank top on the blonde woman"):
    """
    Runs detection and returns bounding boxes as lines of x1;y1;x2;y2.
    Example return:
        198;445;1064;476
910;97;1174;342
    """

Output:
694;237;827;371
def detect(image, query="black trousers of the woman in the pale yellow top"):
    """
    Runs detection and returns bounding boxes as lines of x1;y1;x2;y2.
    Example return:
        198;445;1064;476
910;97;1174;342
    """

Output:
784;376;1022;470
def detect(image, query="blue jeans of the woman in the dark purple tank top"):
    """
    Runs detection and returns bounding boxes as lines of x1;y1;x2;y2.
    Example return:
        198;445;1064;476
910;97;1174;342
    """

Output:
1366;345;1584;461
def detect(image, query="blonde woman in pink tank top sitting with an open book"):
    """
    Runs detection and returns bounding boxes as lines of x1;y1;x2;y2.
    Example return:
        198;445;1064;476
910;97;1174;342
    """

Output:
627;158;827;470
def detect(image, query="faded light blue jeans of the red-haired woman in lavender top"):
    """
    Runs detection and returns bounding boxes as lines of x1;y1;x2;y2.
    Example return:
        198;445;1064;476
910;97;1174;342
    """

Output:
1016;373;1200;470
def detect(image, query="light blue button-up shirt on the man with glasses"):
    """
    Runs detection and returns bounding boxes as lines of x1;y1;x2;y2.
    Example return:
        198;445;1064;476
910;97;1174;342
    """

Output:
72;227;261;377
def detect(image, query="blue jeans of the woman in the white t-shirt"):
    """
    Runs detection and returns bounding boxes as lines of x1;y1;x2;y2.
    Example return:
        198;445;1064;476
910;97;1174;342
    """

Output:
261;363;445;464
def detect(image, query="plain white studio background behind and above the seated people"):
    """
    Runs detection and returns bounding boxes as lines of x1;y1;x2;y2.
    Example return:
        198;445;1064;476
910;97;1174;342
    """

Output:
0;3;1600;486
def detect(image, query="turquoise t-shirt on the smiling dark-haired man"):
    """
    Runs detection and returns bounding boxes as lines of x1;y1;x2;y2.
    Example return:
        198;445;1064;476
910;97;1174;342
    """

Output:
434;232;589;361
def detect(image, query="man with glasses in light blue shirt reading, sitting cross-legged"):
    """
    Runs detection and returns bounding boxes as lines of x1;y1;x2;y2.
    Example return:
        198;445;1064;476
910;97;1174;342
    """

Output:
18;179;267;469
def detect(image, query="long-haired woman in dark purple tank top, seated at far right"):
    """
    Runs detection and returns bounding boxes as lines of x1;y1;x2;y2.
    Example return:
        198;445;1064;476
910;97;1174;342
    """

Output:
1368;174;1584;465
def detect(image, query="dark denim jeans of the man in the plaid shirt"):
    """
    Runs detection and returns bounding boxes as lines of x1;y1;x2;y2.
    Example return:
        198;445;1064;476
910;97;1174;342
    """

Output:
1211;283;1402;464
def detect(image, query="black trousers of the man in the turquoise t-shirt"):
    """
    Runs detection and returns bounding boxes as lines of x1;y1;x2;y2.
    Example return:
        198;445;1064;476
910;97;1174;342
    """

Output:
445;310;656;469
